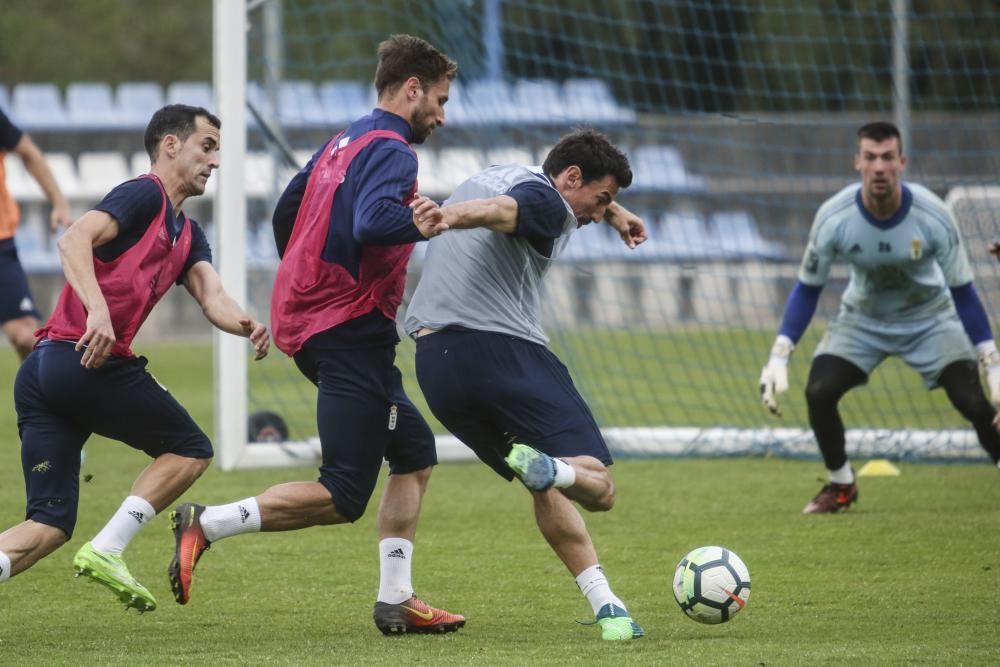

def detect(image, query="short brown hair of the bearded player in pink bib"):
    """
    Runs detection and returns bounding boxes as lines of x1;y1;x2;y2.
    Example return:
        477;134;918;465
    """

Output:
375;35;458;99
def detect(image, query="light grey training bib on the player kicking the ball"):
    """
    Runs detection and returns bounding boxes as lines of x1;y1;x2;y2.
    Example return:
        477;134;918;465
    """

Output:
403;166;577;345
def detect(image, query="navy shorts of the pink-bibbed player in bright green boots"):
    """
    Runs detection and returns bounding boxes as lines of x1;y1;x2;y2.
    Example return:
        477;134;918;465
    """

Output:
14;341;212;537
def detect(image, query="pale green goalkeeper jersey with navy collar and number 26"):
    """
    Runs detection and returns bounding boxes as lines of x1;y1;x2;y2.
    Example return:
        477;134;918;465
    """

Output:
798;184;972;322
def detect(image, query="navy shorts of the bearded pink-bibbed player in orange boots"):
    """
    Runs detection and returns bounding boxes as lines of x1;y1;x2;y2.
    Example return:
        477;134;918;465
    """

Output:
295;341;437;521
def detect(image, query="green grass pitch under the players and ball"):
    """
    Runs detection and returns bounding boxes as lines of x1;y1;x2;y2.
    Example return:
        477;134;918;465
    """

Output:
0;346;1000;665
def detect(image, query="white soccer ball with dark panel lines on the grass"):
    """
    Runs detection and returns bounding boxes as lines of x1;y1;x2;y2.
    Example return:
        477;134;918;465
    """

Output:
674;547;750;625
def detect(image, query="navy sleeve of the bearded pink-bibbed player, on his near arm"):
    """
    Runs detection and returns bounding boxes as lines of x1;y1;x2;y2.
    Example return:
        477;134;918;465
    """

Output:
354;139;426;245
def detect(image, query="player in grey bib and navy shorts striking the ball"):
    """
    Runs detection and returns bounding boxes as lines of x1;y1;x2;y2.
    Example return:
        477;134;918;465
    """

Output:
405;130;646;640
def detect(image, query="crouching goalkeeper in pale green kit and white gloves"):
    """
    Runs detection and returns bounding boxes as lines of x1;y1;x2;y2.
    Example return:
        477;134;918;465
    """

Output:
760;122;1000;514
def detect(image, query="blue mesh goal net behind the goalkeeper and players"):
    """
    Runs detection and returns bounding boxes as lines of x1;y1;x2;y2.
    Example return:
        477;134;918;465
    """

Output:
216;0;1000;467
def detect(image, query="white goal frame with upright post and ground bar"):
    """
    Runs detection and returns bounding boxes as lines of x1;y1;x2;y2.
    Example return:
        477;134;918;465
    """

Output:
213;0;1000;470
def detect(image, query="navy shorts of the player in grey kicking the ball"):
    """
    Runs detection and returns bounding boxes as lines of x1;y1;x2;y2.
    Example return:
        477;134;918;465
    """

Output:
416;329;612;480
